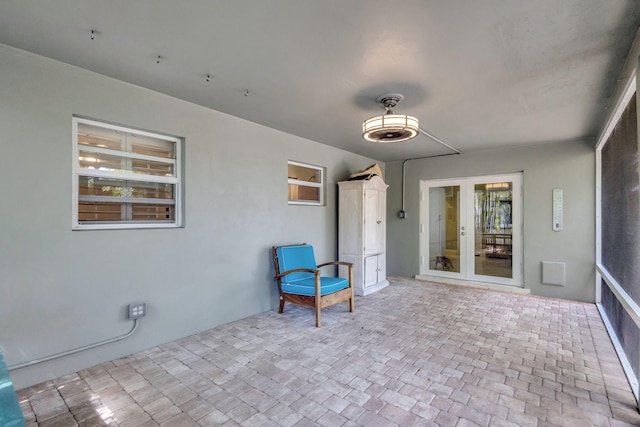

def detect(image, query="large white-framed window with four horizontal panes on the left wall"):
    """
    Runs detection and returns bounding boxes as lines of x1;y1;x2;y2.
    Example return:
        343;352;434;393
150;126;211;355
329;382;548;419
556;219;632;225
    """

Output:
72;117;182;230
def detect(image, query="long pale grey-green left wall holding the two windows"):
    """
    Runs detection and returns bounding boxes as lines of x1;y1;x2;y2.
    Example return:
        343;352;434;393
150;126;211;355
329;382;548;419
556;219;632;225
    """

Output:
0;45;374;388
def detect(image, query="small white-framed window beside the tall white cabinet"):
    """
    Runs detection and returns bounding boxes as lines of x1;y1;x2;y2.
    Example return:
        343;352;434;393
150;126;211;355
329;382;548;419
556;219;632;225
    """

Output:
288;160;325;206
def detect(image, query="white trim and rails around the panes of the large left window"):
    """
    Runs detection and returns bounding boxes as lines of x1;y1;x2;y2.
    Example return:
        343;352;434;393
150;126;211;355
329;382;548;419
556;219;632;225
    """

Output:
71;116;183;230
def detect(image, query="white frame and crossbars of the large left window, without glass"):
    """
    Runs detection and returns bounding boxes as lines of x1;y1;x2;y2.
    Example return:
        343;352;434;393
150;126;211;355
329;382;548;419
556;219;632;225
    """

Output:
71;116;184;230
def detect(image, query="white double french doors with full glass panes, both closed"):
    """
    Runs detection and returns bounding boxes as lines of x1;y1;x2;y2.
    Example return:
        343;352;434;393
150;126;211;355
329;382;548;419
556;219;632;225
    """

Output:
420;174;523;287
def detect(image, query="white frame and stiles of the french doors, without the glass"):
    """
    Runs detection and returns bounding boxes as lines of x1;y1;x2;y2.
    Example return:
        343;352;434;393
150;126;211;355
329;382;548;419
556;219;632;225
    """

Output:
419;173;524;288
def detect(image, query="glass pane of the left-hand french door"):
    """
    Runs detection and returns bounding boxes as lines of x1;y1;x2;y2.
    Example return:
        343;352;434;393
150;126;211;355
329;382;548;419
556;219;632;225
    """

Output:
429;185;460;273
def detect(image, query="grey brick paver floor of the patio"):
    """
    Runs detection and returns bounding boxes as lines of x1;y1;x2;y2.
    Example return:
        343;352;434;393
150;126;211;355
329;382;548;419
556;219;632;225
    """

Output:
18;278;640;427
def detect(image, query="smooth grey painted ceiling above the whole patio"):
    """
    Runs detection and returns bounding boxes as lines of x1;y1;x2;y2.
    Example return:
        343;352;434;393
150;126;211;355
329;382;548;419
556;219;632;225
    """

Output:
0;0;640;161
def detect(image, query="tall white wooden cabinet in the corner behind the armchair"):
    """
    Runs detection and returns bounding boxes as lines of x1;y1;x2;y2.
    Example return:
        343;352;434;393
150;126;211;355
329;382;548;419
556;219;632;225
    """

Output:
338;176;389;295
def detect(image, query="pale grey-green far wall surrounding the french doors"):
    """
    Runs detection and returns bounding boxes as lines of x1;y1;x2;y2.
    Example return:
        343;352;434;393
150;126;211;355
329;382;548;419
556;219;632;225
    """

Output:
386;141;595;302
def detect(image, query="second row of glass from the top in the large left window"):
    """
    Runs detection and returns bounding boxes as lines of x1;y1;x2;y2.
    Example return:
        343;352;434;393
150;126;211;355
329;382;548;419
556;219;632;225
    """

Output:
78;151;175;176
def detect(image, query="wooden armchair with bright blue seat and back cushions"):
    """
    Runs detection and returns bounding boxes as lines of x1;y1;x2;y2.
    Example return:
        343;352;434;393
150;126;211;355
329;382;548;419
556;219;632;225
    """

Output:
273;244;354;327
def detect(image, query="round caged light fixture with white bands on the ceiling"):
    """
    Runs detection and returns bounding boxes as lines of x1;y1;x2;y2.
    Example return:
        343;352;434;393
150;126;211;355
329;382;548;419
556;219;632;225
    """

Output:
362;93;420;144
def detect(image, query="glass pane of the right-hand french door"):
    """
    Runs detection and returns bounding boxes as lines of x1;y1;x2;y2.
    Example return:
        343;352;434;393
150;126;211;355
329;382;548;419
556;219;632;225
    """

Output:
474;182;513;278
